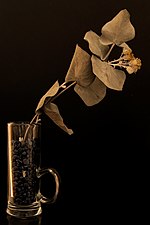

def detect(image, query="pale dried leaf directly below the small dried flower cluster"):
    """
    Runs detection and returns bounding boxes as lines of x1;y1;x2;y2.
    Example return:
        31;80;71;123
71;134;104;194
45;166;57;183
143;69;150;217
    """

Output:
91;55;126;91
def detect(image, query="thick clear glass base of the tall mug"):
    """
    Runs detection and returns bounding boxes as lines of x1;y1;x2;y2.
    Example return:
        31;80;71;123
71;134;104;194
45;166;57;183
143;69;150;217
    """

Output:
6;203;42;218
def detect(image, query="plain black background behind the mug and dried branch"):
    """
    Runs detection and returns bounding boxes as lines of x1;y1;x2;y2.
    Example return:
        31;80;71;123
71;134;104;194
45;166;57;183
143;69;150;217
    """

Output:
0;0;150;225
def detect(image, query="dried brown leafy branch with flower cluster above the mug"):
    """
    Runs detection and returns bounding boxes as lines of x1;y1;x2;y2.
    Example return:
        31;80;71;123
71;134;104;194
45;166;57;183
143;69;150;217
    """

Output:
25;9;141;135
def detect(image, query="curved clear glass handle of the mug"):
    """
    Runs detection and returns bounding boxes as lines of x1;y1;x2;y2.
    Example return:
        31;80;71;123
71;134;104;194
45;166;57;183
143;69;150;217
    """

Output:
37;168;60;203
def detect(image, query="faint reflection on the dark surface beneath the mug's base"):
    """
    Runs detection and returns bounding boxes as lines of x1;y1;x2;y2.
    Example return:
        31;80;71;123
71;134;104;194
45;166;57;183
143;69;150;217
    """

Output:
7;215;42;225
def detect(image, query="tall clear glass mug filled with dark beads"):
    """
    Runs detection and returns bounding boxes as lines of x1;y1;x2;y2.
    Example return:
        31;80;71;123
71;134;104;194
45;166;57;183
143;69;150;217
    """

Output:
6;121;60;218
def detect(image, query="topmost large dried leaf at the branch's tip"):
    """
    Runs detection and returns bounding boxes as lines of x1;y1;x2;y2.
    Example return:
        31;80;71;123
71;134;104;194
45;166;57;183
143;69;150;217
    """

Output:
100;9;135;45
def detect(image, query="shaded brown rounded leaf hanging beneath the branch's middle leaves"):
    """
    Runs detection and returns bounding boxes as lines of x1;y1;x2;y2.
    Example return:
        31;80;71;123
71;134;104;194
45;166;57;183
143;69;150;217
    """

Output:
74;77;106;106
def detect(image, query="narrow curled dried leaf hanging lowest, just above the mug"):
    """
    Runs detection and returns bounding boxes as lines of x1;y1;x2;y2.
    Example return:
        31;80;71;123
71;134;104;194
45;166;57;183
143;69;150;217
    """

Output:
43;102;73;135
